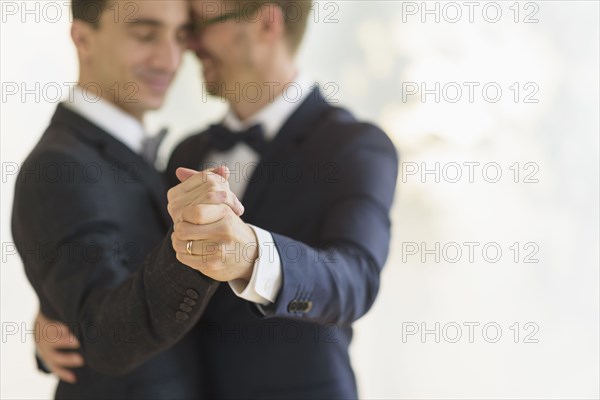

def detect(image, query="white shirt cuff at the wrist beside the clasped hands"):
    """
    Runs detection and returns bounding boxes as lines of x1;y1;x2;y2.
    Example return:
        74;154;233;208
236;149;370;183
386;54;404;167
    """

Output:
228;224;281;306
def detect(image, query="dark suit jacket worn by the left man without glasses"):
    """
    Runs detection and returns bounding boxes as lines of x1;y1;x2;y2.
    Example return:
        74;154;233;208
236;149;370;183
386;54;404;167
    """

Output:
12;105;218;399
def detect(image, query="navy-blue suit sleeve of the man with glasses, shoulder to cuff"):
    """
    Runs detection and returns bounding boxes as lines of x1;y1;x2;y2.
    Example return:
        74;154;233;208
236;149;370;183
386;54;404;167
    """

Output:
261;124;398;325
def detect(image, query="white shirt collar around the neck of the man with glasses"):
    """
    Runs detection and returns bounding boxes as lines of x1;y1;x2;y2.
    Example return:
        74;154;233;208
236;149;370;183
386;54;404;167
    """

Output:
223;74;314;140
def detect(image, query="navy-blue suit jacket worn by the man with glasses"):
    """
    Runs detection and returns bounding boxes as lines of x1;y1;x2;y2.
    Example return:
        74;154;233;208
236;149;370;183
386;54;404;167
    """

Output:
167;91;398;399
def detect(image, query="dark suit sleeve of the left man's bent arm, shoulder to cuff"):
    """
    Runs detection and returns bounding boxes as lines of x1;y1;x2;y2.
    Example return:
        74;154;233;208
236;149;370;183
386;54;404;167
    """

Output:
13;152;218;375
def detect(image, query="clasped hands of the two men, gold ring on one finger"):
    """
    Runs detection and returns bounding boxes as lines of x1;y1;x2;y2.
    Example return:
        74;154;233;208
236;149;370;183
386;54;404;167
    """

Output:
167;166;258;282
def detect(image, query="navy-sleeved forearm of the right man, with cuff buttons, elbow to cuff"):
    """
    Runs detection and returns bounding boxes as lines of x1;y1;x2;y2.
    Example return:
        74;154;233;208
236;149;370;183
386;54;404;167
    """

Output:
262;234;382;325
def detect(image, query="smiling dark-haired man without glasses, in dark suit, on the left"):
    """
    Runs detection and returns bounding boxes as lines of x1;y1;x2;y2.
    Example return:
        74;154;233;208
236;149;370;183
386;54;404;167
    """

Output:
12;0;242;399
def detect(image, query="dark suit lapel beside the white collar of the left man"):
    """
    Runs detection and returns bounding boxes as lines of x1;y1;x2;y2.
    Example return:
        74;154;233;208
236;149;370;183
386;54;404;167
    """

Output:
52;104;171;229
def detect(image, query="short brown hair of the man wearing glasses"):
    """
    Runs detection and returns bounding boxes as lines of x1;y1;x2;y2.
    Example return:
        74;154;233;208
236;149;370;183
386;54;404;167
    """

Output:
225;0;312;53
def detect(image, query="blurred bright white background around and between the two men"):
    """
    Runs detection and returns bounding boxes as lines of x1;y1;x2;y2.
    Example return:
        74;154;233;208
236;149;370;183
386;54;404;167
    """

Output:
0;0;600;399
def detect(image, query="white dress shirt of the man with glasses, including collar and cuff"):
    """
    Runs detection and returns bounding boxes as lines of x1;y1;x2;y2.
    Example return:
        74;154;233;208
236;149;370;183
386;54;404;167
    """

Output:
207;74;314;305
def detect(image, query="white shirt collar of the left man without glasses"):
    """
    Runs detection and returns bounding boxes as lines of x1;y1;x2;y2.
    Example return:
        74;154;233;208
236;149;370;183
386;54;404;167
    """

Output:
65;86;147;153
